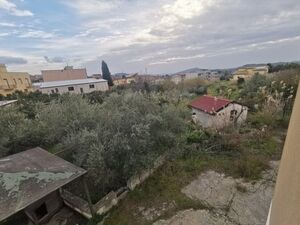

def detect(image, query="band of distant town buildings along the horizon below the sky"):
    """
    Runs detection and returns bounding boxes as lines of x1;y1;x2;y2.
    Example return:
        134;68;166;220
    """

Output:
0;59;296;96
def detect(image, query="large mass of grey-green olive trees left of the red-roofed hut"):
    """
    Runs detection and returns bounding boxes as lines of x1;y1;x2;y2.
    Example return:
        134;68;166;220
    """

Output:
0;91;187;200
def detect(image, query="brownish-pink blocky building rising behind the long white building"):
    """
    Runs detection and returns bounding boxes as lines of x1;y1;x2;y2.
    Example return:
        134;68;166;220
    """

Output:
42;66;87;82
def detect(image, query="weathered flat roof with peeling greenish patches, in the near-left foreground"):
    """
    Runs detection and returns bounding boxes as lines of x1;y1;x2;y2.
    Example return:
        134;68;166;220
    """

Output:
0;147;86;221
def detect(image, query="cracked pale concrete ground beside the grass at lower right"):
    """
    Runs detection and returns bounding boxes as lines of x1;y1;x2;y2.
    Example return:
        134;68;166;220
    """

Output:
153;161;279;225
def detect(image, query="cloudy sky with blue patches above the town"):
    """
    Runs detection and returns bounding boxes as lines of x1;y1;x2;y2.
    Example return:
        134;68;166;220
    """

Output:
0;0;300;74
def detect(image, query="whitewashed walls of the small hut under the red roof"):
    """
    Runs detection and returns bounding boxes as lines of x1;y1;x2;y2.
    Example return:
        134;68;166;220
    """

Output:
192;103;248;129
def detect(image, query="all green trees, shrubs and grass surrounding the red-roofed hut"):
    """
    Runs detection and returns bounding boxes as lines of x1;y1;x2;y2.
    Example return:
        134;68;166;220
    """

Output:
0;70;299;225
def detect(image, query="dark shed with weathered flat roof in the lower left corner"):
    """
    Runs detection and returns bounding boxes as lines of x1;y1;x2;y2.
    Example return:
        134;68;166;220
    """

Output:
0;148;86;225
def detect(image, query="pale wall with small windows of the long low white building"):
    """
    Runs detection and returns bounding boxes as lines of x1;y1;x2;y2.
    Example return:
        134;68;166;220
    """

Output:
39;82;108;94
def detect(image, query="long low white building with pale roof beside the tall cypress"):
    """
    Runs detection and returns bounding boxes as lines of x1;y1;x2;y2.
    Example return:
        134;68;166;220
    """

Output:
34;78;108;94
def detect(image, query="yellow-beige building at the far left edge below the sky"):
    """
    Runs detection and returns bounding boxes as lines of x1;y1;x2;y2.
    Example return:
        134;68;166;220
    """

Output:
0;64;32;96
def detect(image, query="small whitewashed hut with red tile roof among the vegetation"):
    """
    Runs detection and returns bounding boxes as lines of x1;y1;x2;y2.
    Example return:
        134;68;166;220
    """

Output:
190;95;248;129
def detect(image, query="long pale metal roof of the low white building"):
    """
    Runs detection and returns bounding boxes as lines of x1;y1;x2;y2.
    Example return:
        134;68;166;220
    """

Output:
34;78;107;88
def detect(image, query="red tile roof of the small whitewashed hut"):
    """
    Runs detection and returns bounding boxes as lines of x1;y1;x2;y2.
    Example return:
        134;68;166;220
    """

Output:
190;95;233;115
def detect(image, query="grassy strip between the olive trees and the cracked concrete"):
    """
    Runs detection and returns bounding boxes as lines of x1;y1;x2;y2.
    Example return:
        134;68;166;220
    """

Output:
105;125;281;225
